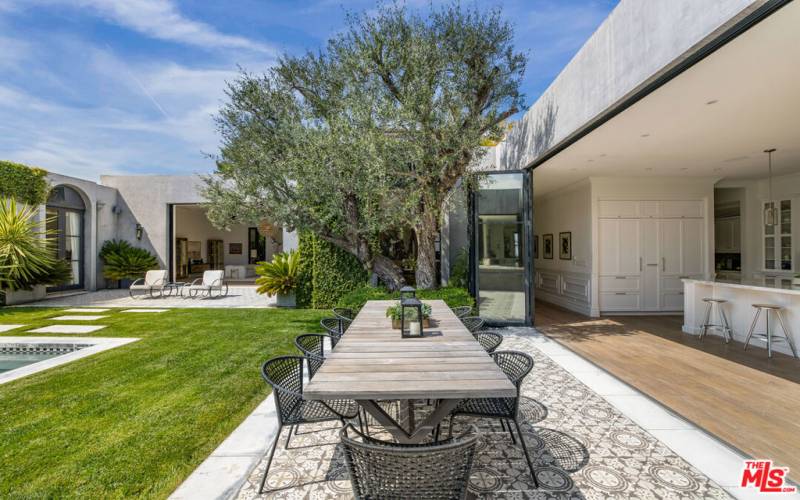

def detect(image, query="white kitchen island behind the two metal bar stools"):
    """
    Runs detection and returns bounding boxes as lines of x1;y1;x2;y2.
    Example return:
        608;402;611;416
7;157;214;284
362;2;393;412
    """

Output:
683;279;800;355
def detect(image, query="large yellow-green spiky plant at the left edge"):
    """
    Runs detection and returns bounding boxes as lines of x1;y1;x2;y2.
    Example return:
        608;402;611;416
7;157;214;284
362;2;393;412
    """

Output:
0;199;72;291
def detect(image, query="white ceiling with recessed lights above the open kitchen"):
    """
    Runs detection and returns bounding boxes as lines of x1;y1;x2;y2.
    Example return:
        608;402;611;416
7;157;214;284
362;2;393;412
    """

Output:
533;2;800;197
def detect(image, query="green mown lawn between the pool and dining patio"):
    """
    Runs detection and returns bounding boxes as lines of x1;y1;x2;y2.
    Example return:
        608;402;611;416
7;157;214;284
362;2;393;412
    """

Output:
0;308;326;498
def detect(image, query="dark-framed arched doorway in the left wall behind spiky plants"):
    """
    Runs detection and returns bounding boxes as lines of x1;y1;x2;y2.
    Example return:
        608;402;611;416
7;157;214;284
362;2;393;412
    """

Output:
47;186;86;292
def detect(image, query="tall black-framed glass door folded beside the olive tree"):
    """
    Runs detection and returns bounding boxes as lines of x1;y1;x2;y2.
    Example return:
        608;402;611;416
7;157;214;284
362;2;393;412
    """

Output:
471;171;532;325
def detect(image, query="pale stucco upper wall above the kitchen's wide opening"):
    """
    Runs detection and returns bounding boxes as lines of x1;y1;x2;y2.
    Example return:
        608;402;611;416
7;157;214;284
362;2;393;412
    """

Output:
481;0;766;170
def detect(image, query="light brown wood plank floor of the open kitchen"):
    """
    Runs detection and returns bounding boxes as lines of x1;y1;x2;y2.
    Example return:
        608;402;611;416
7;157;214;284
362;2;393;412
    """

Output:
534;302;800;480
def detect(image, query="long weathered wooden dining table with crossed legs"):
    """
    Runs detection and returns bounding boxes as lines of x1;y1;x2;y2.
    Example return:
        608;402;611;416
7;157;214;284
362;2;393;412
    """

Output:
303;300;517;444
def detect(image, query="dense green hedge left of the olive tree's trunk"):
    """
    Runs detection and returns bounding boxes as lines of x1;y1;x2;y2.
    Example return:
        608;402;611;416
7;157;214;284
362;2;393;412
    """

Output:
295;233;369;309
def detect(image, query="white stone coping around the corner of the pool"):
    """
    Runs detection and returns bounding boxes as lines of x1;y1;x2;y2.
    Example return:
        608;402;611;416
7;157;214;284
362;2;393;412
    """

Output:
0;336;139;385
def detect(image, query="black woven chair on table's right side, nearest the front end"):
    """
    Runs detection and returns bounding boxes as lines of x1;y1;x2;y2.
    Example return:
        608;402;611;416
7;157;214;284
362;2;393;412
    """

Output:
450;351;539;488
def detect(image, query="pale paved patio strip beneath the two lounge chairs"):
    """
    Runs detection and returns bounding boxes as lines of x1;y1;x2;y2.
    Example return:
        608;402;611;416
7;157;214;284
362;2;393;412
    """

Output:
22;285;276;312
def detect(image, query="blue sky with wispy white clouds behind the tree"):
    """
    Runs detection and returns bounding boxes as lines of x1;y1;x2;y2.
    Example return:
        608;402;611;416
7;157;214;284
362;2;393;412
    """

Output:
0;0;617;180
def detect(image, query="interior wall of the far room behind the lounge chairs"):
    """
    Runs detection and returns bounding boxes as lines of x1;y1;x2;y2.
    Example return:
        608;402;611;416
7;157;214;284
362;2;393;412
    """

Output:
175;206;250;266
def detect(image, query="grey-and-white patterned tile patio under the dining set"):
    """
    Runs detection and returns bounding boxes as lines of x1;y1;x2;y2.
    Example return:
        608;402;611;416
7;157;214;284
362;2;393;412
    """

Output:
238;337;729;499
